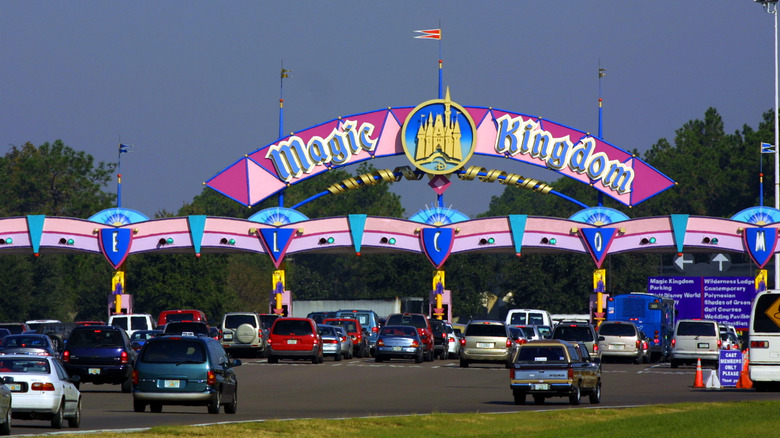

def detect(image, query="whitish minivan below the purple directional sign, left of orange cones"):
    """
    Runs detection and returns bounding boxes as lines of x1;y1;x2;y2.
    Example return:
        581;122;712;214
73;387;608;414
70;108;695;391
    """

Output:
670;319;722;368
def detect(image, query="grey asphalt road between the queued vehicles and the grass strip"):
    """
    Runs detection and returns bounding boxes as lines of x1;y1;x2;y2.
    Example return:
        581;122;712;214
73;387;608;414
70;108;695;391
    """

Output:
7;359;780;435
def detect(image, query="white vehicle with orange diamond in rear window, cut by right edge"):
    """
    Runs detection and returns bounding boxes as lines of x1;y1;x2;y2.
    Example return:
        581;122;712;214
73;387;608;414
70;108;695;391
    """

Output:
748;290;780;391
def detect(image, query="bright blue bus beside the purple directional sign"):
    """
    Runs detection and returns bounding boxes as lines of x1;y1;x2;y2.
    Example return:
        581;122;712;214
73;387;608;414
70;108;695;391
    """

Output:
606;292;676;362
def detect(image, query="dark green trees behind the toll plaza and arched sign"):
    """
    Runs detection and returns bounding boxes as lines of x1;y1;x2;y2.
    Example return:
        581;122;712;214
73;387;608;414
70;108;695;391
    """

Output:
0;108;774;321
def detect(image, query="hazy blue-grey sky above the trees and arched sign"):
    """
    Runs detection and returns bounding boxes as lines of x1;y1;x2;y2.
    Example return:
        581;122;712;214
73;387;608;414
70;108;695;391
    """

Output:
0;0;774;217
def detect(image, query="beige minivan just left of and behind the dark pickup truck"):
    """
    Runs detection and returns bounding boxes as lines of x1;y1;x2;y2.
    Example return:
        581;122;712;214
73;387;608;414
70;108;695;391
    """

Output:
460;320;517;368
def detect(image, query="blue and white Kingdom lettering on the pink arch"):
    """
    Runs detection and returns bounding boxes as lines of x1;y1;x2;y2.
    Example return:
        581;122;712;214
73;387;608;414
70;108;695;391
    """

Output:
495;114;634;194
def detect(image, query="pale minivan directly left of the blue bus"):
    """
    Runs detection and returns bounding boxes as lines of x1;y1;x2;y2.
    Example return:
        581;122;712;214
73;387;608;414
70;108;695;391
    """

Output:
598;321;650;363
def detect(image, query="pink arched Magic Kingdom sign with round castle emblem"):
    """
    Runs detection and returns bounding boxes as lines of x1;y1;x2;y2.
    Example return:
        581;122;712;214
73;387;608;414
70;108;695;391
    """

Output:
205;90;674;206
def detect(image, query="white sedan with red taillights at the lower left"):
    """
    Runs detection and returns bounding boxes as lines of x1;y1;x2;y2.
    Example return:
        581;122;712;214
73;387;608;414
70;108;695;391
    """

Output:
0;355;81;429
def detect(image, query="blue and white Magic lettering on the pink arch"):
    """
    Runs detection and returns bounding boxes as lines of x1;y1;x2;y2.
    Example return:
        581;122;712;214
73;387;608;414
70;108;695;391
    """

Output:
265;120;377;182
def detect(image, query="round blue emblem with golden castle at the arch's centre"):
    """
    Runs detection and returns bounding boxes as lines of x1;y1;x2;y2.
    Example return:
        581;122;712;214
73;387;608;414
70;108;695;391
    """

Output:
401;88;477;175
